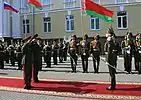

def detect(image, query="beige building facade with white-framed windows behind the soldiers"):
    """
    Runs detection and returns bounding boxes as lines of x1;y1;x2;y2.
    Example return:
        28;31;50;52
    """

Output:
3;0;141;39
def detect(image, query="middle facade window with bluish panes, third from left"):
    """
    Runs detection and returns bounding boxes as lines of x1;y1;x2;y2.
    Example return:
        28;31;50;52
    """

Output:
66;15;74;32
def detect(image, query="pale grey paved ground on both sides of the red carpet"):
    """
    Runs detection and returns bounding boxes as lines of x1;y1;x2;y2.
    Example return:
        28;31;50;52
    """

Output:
0;58;141;100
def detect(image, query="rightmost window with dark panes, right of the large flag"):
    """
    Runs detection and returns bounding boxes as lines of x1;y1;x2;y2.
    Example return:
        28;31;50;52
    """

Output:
117;11;128;29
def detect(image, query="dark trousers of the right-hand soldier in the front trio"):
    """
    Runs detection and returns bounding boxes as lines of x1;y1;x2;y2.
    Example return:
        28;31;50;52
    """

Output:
93;55;100;73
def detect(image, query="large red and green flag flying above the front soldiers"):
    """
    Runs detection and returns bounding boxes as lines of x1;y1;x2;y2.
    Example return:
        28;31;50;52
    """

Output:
82;0;113;23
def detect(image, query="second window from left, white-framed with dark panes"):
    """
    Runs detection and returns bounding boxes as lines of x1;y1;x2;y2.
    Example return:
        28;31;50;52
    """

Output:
43;17;51;32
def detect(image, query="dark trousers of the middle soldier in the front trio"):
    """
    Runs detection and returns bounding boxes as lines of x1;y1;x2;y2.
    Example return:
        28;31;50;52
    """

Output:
81;55;88;73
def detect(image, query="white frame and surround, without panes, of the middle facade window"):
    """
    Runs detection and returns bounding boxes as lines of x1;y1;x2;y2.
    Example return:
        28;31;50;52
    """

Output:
65;15;75;32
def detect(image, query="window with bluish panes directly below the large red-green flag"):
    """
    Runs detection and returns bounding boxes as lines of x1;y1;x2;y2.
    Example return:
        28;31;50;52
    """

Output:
90;16;100;30
